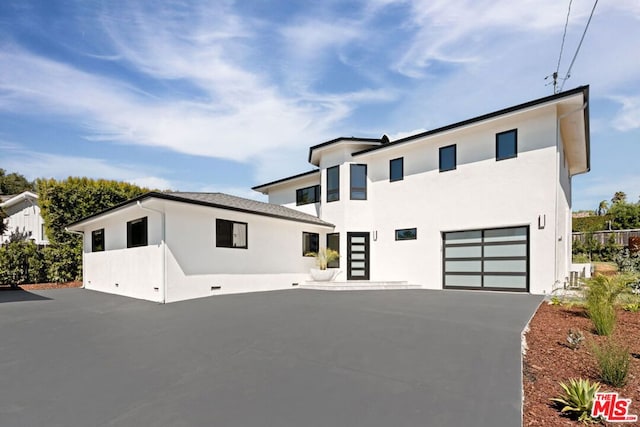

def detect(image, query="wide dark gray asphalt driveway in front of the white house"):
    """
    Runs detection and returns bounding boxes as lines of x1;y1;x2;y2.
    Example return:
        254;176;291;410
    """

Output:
0;289;541;427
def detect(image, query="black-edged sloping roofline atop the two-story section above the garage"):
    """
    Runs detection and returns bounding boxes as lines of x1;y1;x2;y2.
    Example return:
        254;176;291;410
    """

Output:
352;86;591;172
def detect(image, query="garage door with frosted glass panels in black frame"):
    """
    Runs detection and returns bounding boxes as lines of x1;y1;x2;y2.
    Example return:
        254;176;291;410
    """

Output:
442;227;529;292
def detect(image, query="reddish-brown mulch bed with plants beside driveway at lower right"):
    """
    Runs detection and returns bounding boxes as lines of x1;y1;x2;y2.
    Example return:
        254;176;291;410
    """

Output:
523;303;640;427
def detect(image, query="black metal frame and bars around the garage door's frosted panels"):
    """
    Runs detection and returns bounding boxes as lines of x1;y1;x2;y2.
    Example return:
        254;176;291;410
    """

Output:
441;225;531;292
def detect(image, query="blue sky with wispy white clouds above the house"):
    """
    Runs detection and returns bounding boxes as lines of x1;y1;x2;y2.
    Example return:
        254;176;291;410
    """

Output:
0;0;640;209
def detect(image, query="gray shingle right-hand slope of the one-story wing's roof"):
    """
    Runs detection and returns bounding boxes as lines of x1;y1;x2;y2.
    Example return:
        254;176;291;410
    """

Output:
165;192;333;227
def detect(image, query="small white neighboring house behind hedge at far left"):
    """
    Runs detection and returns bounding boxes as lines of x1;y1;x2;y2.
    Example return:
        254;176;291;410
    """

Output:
0;191;49;245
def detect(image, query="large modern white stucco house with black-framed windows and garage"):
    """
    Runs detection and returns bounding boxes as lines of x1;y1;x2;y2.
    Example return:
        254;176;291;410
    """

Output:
69;86;590;302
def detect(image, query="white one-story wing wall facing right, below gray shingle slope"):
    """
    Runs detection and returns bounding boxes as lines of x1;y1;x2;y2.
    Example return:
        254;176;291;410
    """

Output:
164;202;331;302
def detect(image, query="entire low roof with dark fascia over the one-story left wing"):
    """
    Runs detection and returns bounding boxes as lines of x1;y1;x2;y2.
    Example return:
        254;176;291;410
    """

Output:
67;191;334;228
